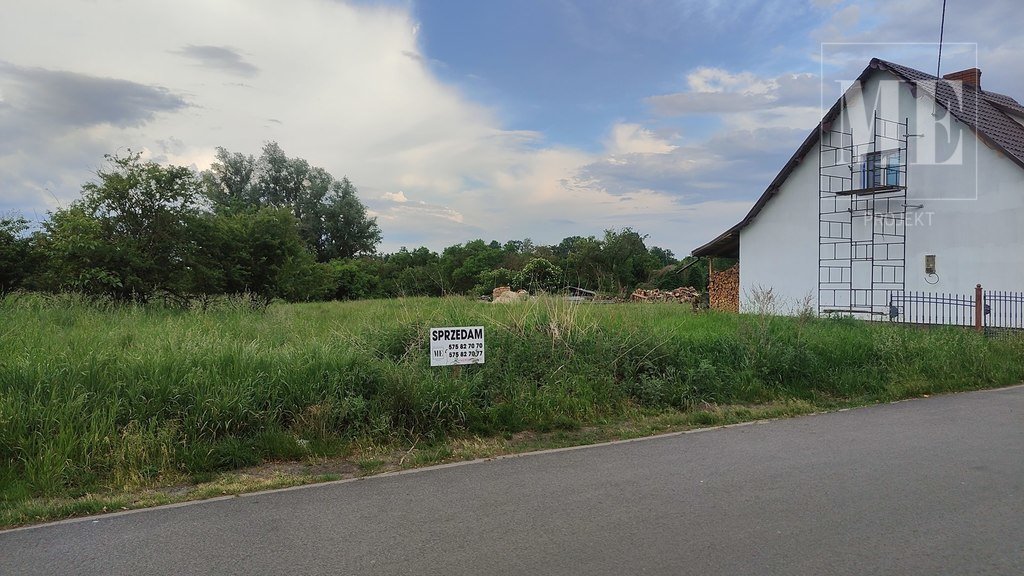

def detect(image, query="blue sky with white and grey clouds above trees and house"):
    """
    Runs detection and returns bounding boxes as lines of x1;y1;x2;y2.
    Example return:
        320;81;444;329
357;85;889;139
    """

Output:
0;0;1024;255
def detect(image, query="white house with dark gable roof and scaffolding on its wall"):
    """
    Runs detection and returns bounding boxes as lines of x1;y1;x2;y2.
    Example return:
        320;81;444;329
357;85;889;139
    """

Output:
692;58;1024;316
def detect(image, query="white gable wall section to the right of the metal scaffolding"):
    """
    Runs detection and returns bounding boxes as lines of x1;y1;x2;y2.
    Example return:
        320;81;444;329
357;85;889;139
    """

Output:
901;73;1024;294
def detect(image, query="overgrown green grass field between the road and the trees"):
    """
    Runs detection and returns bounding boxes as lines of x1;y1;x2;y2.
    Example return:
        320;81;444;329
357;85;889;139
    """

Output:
0;295;1024;520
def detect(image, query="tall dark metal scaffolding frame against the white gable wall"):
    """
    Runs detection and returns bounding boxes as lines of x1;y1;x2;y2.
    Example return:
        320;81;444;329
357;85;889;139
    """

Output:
818;112;909;316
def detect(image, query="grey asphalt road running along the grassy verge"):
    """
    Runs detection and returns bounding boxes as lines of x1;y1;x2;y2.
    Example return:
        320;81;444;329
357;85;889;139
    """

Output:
0;386;1024;576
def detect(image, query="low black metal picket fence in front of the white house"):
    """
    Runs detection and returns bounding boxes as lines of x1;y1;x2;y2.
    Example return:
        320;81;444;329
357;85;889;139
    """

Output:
889;285;1024;330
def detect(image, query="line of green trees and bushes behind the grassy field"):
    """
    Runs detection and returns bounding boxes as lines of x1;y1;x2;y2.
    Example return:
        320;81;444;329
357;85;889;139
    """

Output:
0;142;724;302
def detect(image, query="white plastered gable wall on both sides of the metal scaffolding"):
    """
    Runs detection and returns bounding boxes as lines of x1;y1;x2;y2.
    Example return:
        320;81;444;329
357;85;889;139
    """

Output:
739;72;1024;312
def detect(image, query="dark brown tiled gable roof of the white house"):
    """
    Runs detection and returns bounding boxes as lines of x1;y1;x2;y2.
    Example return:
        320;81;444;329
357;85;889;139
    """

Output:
690;58;1024;258
